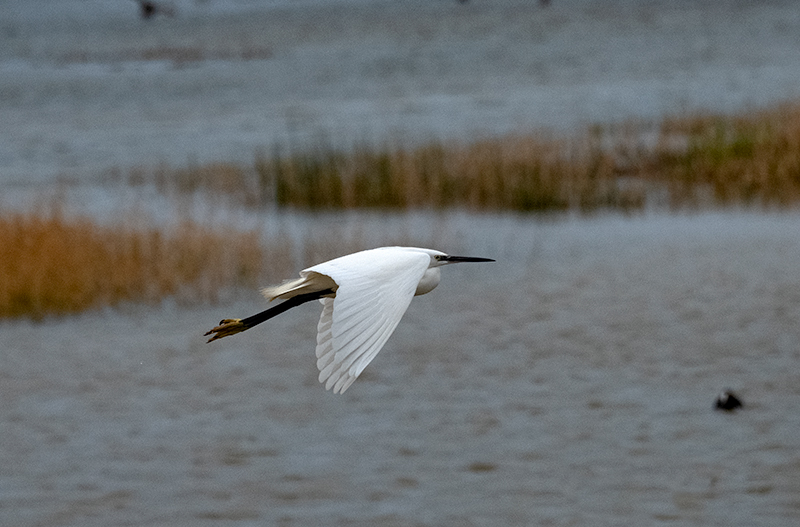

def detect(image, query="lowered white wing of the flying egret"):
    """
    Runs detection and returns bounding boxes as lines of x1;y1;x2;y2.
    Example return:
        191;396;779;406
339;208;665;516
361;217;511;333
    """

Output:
306;248;430;393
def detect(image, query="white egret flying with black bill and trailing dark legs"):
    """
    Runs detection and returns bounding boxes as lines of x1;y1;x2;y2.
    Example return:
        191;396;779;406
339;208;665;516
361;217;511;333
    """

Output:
206;247;494;393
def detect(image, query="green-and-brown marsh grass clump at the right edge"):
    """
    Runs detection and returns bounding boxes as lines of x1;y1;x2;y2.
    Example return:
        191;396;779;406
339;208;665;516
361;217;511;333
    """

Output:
643;104;800;207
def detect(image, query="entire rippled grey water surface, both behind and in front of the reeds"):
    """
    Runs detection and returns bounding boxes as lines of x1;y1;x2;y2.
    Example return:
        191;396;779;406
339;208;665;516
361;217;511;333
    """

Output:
0;0;800;527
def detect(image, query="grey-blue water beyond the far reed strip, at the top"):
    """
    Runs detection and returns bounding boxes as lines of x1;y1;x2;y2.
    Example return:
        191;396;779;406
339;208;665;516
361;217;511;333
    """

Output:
0;0;800;183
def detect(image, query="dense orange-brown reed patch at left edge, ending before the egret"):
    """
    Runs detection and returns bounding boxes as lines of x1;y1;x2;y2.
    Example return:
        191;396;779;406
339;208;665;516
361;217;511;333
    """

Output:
0;212;263;318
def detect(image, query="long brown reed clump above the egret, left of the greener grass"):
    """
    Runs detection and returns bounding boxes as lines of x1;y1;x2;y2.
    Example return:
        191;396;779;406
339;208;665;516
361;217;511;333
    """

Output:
256;136;638;211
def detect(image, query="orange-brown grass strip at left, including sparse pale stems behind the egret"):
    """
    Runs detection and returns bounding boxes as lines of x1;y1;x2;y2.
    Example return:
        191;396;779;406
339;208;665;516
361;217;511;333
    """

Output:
0;203;436;320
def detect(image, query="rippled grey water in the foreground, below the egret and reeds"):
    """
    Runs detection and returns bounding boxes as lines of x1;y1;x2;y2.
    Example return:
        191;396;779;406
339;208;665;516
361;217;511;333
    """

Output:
0;212;800;527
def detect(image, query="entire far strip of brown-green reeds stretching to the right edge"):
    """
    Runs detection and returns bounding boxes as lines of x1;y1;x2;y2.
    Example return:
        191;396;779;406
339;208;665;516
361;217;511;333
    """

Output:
129;104;800;211
